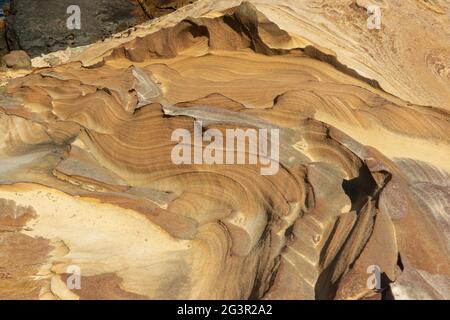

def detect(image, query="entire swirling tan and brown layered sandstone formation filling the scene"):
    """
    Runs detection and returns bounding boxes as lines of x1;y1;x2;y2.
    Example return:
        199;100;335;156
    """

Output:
0;0;450;299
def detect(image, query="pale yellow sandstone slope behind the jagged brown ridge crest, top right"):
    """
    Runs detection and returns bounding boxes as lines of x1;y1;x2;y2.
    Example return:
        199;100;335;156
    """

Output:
29;0;450;110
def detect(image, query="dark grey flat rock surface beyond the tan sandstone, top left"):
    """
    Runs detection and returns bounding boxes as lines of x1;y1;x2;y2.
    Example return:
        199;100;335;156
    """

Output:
7;0;147;57
